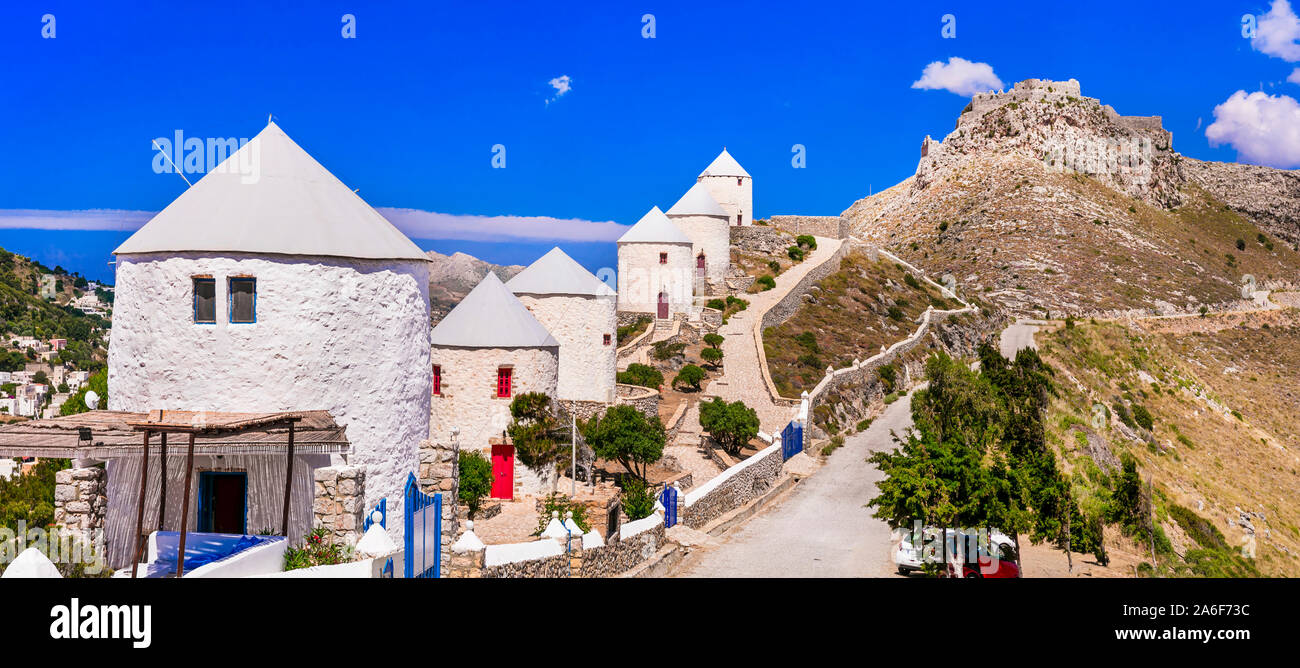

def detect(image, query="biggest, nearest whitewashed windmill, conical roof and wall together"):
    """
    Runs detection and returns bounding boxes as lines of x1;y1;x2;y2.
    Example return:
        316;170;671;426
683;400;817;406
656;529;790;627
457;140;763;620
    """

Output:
94;118;432;567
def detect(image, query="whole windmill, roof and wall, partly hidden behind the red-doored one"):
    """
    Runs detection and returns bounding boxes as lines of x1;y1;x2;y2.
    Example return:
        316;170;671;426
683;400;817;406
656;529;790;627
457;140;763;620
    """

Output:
506;248;618;404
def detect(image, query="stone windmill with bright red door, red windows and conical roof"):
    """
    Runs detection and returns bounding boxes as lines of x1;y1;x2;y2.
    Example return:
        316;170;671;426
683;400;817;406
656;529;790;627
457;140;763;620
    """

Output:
429;272;560;499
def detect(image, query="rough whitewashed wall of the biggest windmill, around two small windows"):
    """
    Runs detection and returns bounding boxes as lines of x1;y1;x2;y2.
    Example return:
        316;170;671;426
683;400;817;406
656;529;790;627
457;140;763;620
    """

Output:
108;253;433;539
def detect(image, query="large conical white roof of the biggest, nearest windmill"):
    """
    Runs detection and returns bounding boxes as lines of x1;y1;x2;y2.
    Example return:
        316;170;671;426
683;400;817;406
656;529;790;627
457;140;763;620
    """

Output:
113;123;426;261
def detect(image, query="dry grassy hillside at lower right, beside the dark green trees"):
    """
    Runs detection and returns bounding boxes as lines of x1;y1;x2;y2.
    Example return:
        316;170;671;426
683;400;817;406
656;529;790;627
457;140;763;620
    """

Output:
1037;308;1300;576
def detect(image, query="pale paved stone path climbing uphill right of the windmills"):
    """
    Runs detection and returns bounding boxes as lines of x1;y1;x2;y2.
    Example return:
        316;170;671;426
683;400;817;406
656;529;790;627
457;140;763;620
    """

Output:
712;237;844;433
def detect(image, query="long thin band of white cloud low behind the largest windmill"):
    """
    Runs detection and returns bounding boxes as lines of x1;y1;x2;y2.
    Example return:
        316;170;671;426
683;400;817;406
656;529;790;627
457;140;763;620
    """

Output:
0;207;628;242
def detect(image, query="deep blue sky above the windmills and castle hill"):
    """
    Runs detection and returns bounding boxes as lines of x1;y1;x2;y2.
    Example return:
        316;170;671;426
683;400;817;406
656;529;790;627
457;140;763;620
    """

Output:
0;1;1300;278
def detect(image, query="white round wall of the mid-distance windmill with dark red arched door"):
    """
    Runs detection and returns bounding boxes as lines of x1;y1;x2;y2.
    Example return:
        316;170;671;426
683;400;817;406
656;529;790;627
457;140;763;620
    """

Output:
619;242;696;316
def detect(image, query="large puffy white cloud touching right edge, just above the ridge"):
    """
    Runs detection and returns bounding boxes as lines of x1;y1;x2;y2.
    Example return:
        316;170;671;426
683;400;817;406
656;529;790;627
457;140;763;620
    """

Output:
1205;91;1300;169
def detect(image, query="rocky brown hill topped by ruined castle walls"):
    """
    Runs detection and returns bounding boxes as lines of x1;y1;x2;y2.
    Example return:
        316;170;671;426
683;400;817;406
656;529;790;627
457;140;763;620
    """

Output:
844;79;1300;313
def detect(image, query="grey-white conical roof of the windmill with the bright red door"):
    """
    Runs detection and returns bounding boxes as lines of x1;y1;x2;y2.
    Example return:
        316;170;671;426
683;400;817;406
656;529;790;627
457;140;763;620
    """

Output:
430;272;559;348
